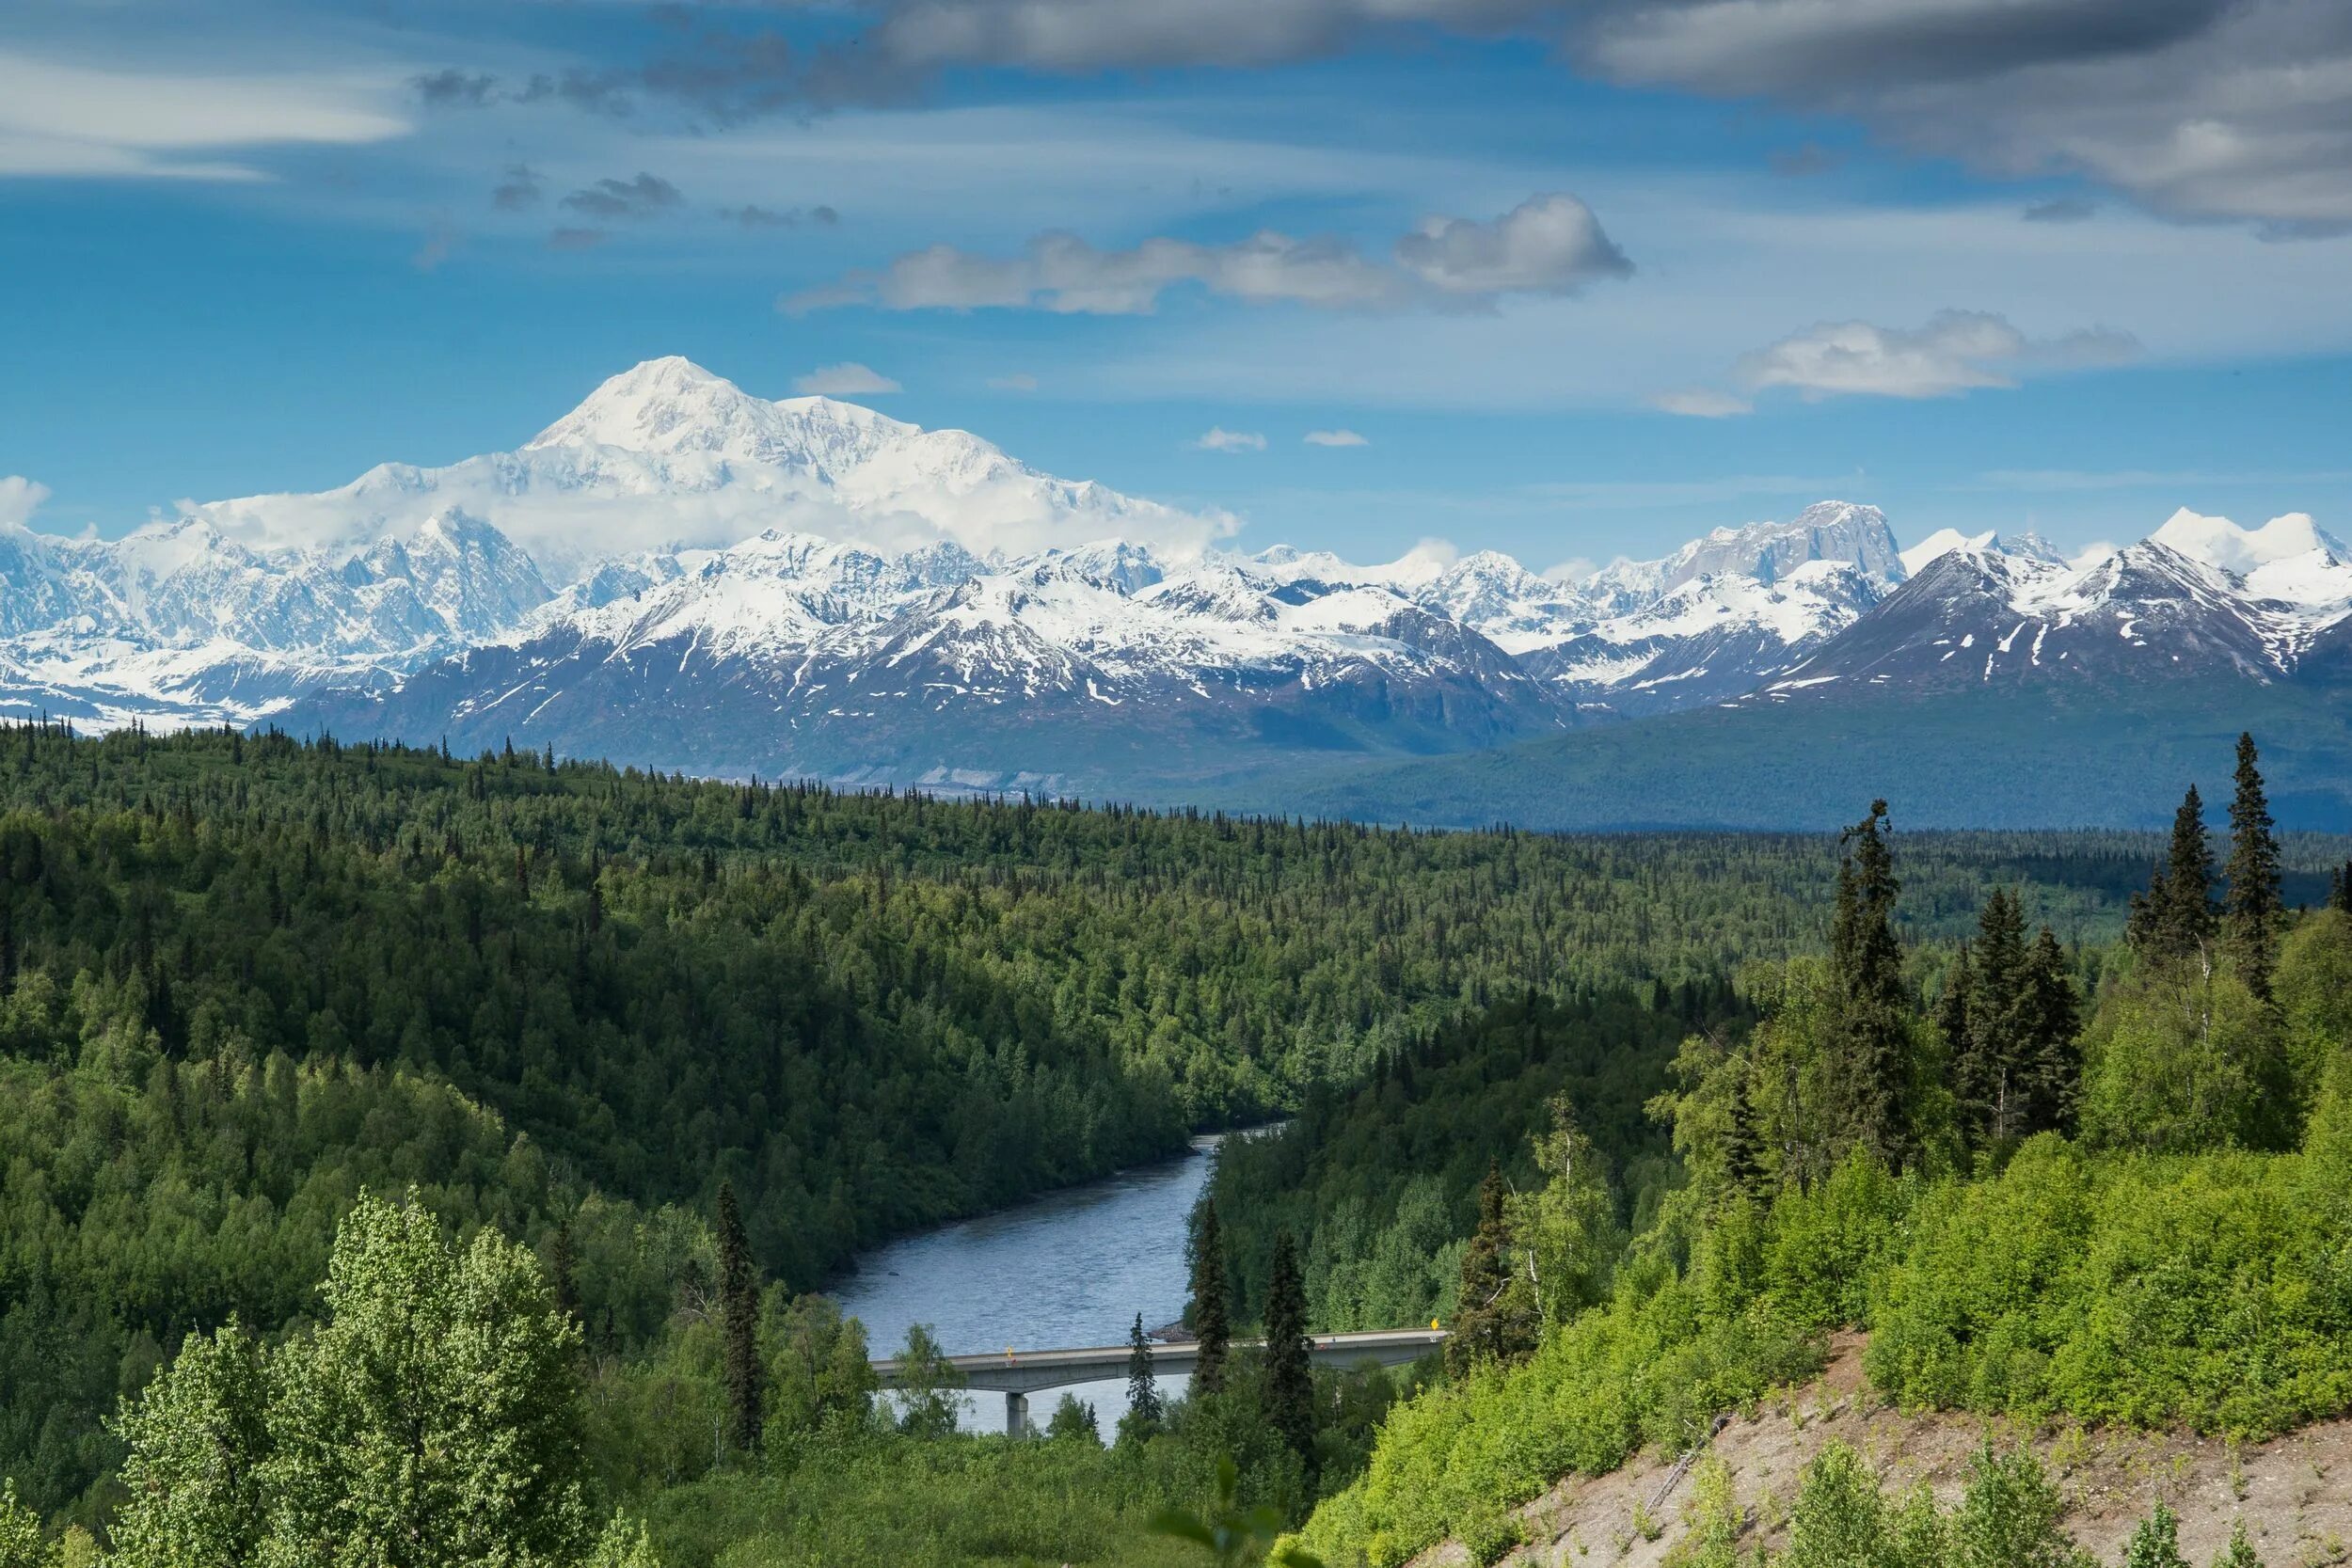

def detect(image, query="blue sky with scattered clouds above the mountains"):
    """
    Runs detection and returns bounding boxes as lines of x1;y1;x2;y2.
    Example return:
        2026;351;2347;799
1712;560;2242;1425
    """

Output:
0;0;2352;569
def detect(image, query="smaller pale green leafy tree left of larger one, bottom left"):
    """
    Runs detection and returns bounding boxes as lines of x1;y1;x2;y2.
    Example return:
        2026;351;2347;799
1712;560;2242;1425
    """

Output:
113;1322;271;1568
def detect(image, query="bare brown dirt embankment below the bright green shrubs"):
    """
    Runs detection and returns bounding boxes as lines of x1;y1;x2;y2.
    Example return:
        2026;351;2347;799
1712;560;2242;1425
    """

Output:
1421;1336;2352;1568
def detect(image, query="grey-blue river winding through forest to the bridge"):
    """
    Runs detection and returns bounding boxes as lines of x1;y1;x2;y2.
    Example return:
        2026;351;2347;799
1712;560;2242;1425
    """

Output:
831;1138;1216;1439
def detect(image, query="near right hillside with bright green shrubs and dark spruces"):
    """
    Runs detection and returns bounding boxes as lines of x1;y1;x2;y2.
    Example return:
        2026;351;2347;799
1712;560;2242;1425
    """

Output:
1251;738;2352;1568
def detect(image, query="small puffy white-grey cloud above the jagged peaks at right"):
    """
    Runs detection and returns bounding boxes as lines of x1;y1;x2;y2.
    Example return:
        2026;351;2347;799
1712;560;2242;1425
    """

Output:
1734;310;2140;397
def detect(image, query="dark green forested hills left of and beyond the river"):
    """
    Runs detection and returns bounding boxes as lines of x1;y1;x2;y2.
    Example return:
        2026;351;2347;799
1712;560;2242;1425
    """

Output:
0;726;2343;1561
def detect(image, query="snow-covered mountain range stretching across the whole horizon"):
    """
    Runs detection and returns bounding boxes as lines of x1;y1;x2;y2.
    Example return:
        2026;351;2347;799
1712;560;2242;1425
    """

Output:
0;359;2352;822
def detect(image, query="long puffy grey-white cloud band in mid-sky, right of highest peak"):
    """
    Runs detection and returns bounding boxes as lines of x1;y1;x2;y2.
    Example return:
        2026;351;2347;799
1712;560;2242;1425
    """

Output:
779;195;1632;315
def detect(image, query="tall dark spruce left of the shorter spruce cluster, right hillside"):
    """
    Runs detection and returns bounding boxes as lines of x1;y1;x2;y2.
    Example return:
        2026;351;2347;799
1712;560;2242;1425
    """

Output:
1830;800;1913;1168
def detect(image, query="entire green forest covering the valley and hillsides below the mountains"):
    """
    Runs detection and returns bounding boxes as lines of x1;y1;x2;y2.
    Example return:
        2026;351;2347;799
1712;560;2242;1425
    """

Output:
0;724;2352;1568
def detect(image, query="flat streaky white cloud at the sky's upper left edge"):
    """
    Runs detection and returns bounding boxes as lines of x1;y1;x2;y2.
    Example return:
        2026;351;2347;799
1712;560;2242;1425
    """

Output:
0;52;412;181
